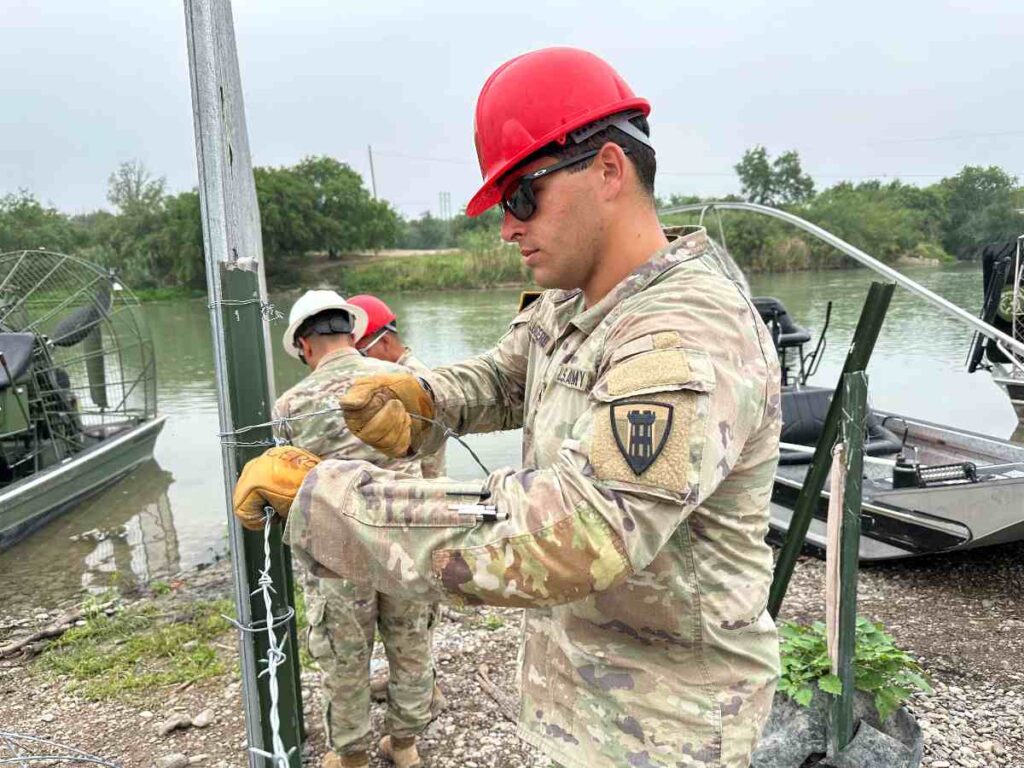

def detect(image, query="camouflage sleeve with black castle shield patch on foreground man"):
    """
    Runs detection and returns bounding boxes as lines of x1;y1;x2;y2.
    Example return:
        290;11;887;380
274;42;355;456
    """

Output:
293;274;777;606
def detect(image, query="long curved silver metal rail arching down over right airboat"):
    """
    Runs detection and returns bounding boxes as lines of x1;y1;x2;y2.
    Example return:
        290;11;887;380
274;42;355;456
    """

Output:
657;202;1024;355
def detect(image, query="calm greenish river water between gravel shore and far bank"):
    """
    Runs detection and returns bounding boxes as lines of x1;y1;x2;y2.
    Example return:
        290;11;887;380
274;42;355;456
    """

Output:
0;265;1016;612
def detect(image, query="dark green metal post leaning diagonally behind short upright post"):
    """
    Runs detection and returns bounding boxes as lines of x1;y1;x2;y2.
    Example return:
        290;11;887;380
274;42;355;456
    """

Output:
768;283;896;618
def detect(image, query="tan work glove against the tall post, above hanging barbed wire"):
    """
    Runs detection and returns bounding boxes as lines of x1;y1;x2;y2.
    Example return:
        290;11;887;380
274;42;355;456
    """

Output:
231;445;319;530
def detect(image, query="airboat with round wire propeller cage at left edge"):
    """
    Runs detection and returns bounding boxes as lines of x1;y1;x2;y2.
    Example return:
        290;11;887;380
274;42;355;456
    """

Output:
0;250;164;550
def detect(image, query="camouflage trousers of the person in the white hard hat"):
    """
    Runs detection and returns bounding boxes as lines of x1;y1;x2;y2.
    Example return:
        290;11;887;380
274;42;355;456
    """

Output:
303;574;437;754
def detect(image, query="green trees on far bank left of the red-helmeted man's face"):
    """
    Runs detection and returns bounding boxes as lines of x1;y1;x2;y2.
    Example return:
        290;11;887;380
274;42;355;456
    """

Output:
0;157;402;289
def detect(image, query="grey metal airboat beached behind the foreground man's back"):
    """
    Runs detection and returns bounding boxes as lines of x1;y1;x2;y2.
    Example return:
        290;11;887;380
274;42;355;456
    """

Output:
659;202;1024;561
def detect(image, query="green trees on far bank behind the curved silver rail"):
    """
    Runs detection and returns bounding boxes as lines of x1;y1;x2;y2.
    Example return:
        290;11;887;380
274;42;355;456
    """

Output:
666;146;1024;271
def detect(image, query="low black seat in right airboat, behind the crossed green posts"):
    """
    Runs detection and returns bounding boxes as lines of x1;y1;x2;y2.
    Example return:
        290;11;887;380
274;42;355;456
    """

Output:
779;387;903;464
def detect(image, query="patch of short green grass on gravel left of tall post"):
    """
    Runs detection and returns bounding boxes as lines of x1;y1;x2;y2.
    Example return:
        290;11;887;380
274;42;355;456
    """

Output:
36;600;234;700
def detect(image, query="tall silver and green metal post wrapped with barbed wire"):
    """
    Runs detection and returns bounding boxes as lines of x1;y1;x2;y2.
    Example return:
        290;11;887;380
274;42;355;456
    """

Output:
184;0;302;768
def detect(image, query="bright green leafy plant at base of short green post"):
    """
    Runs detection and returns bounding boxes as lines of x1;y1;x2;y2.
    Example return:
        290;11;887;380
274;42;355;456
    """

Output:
778;616;932;721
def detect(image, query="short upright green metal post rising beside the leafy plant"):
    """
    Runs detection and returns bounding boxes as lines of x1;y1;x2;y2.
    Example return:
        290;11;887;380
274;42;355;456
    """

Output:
828;371;867;755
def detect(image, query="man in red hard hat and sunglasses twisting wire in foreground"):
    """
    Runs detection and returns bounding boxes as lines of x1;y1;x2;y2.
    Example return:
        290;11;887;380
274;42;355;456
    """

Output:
236;49;780;768
